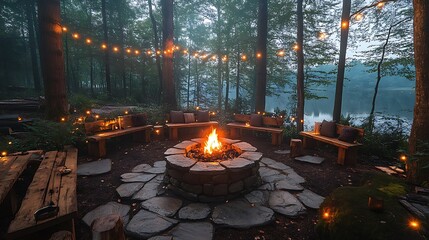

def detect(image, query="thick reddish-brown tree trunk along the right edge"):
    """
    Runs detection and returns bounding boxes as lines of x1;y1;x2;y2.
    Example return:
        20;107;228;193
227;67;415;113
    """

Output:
409;0;429;154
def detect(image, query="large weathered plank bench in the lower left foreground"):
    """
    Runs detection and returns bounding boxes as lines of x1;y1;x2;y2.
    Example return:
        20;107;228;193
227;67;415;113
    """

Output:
7;148;77;239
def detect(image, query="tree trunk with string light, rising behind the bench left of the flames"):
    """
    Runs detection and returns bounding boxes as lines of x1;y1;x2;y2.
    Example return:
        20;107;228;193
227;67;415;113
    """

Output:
161;0;177;109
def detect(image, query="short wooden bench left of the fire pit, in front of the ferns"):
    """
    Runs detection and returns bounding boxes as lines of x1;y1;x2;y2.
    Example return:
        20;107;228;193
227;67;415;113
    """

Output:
87;125;153;158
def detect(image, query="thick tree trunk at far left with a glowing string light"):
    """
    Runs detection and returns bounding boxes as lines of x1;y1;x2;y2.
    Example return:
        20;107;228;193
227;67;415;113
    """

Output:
38;0;68;121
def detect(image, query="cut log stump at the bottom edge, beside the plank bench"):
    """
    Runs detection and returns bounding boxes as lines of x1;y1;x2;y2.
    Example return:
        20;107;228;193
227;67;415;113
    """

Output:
92;214;125;240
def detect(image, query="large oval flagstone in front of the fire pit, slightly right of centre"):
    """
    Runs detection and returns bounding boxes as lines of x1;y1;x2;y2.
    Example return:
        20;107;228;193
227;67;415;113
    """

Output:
212;200;274;228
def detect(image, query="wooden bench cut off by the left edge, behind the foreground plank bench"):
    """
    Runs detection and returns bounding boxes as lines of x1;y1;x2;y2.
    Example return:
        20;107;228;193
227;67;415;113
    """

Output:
0;150;43;214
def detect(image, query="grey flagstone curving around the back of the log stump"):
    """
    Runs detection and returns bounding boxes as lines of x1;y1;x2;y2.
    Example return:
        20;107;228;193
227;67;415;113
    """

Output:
82;202;130;227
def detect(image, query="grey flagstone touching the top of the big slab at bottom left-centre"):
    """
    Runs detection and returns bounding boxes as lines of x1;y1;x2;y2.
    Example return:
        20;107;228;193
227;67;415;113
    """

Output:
141;197;182;217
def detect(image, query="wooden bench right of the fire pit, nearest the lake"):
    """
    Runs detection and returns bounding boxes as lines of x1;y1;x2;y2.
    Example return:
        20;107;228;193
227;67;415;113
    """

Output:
299;123;364;165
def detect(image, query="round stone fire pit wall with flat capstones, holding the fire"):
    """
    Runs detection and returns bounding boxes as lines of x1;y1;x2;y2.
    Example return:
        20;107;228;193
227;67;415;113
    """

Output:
164;138;262;202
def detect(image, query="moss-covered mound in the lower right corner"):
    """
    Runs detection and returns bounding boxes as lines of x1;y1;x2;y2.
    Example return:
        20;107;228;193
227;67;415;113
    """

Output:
316;173;424;240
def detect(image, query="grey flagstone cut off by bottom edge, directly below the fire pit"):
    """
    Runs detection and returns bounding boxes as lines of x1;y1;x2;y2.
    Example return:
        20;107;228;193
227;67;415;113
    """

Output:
169;222;214;240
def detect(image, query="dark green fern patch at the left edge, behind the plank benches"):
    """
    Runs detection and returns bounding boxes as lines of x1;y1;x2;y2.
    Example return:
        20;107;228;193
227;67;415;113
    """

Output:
0;120;85;152
